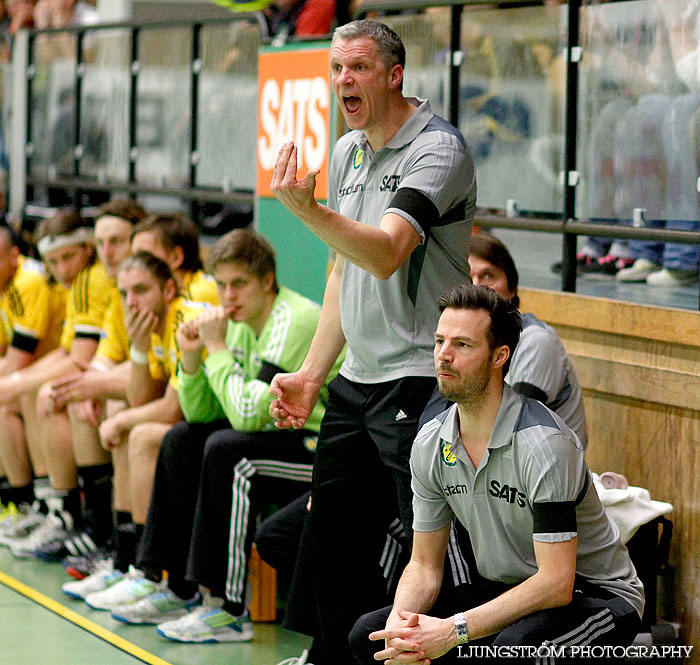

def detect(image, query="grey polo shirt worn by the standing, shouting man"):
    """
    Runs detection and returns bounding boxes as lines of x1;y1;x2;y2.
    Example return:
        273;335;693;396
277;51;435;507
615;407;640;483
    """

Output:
328;99;476;383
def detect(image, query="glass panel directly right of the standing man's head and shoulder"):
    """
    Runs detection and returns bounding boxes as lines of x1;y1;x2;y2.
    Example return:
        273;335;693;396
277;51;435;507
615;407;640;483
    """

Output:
459;6;566;213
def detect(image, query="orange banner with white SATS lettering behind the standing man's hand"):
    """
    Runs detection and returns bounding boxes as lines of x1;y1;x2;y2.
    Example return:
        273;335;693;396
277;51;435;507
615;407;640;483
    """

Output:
257;49;331;199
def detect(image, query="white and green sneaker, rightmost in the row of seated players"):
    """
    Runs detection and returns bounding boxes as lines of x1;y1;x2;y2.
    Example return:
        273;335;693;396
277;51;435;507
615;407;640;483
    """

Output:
158;605;253;644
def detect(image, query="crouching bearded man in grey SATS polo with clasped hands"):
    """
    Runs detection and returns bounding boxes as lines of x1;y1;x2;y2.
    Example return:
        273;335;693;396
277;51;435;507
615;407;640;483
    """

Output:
350;285;644;664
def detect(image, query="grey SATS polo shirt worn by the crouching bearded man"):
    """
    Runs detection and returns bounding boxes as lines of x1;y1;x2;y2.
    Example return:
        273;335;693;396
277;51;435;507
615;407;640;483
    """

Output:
411;386;644;616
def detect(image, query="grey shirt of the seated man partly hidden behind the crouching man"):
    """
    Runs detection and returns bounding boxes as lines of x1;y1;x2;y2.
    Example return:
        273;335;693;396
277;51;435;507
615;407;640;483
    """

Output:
506;314;588;450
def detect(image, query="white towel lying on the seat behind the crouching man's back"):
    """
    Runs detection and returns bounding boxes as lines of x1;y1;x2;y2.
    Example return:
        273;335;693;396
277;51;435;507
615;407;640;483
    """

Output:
592;473;673;543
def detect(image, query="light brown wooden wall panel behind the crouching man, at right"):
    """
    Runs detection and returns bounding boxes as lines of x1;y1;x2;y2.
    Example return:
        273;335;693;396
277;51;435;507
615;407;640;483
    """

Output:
520;289;700;665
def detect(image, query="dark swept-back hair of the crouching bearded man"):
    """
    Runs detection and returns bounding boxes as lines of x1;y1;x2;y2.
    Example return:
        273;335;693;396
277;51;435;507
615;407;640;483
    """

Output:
437;284;523;376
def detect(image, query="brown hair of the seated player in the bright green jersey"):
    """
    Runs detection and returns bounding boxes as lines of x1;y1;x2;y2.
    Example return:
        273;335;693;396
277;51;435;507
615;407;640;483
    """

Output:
207;229;279;293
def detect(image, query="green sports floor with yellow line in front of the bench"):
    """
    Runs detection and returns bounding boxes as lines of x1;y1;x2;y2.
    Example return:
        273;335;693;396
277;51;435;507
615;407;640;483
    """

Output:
0;548;310;665
